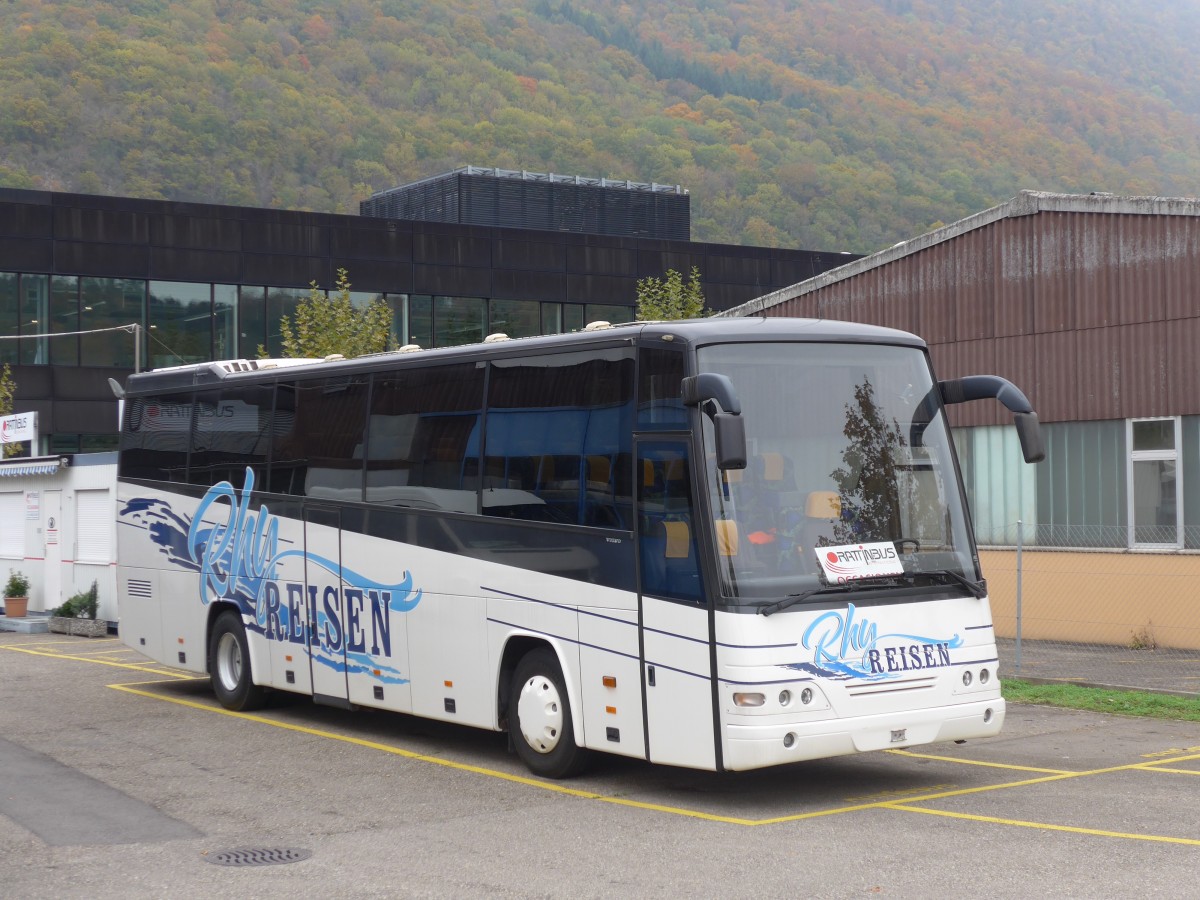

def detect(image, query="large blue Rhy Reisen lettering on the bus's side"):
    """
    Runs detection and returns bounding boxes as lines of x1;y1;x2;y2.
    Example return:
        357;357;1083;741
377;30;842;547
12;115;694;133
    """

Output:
187;468;421;656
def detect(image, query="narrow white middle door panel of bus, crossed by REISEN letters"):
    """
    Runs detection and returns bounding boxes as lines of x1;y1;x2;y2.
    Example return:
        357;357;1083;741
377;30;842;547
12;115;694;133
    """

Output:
304;506;349;706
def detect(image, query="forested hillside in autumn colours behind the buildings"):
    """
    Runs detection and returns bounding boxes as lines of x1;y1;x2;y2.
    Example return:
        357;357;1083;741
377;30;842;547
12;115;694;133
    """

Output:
0;0;1200;252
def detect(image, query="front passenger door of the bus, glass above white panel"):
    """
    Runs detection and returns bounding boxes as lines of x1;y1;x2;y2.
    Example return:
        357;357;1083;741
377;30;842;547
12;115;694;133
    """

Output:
635;438;716;768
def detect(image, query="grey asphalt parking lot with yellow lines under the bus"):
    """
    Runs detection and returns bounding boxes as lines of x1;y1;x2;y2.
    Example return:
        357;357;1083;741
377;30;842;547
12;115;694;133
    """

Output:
0;632;1200;898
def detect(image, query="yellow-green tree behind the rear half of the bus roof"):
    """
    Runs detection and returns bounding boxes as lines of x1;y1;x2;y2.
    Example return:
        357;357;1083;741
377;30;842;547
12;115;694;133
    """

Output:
258;269;396;359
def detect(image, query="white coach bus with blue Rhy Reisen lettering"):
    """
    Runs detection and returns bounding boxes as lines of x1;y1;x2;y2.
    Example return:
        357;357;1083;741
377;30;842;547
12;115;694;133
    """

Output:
118;318;1042;778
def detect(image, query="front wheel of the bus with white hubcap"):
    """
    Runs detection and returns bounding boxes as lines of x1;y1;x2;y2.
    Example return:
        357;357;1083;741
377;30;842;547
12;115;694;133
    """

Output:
509;647;588;779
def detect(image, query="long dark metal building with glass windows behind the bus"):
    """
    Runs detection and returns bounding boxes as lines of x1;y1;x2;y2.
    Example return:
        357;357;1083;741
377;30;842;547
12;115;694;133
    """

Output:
0;188;847;452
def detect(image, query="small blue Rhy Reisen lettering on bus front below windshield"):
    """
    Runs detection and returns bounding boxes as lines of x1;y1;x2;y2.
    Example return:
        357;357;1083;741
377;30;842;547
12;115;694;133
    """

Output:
802;604;962;678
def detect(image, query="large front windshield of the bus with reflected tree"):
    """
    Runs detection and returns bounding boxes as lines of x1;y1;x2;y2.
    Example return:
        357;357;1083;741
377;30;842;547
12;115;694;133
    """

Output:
698;343;979;605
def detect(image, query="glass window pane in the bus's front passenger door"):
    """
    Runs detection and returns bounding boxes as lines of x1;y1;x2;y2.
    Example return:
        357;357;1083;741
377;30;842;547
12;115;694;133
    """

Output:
636;440;704;604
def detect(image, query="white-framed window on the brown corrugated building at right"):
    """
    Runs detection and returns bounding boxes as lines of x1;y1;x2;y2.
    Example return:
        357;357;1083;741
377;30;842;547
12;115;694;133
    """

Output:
1127;416;1183;548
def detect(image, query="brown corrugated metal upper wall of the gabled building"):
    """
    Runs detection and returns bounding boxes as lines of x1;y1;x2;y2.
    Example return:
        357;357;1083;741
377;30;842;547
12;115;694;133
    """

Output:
764;211;1200;425
